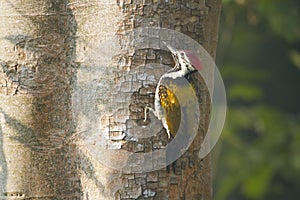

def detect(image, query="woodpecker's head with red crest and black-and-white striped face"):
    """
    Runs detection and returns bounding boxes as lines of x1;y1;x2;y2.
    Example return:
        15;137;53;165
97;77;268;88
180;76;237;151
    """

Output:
165;44;203;72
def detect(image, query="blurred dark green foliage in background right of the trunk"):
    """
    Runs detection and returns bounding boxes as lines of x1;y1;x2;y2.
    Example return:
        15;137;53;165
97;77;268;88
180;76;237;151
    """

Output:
213;0;300;200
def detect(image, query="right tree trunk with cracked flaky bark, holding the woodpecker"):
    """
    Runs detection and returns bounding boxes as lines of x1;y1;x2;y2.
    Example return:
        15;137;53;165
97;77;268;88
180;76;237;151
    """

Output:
72;0;221;200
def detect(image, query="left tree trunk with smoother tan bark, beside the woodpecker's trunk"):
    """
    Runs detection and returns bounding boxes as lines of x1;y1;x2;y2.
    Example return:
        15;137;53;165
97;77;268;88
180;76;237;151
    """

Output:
0;0;82;199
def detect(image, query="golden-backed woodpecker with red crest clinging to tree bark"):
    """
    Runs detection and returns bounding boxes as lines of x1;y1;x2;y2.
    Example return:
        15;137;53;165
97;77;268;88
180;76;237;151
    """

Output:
144;43;202;172
